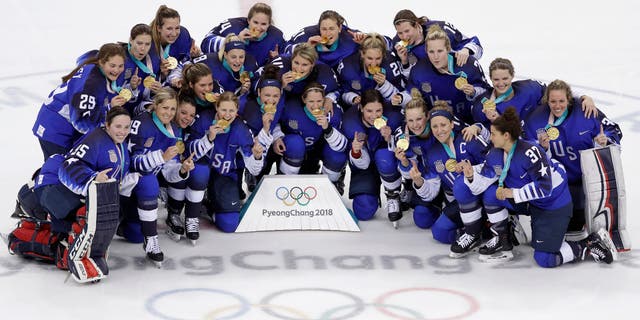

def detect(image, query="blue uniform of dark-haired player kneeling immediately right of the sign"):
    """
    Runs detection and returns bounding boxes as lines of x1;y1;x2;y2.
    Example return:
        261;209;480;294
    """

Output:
342;106;403;220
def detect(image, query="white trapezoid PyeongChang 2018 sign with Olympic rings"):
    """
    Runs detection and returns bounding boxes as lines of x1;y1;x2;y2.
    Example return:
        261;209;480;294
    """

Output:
236;175;360;232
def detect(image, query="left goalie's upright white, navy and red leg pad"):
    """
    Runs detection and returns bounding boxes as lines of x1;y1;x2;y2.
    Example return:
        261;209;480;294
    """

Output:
67;180;119;283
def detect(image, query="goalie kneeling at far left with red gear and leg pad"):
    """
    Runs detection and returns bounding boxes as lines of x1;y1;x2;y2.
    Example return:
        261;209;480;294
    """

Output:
8;107;131;282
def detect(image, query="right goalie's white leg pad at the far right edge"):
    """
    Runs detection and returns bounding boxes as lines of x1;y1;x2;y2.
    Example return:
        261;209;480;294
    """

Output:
580;145;631;252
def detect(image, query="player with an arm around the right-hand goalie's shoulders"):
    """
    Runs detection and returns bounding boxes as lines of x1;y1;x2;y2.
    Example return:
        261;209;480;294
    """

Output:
472;58;596;128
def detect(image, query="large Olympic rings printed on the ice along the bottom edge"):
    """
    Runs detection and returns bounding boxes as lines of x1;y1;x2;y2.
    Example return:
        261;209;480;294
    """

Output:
145;287;480;320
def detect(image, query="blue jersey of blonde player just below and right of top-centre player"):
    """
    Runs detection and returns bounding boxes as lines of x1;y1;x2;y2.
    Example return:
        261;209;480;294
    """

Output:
338;52;404;105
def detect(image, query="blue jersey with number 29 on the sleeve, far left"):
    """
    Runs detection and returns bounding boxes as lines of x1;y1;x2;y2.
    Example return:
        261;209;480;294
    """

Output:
32;64;121;159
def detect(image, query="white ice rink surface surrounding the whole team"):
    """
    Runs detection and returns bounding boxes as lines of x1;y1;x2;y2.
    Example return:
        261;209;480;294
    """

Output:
0;0;640;320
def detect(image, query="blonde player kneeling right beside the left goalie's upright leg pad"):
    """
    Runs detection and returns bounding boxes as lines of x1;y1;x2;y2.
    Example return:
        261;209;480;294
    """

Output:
122;88;194;267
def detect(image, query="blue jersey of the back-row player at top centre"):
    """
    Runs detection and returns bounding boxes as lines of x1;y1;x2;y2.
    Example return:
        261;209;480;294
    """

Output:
284;25;360;69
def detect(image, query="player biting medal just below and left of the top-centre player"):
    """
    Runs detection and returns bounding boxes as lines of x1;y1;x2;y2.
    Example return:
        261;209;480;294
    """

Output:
258;43;340;112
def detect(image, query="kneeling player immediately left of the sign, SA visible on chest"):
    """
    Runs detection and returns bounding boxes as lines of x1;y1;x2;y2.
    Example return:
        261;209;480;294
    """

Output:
187;91;266;232
